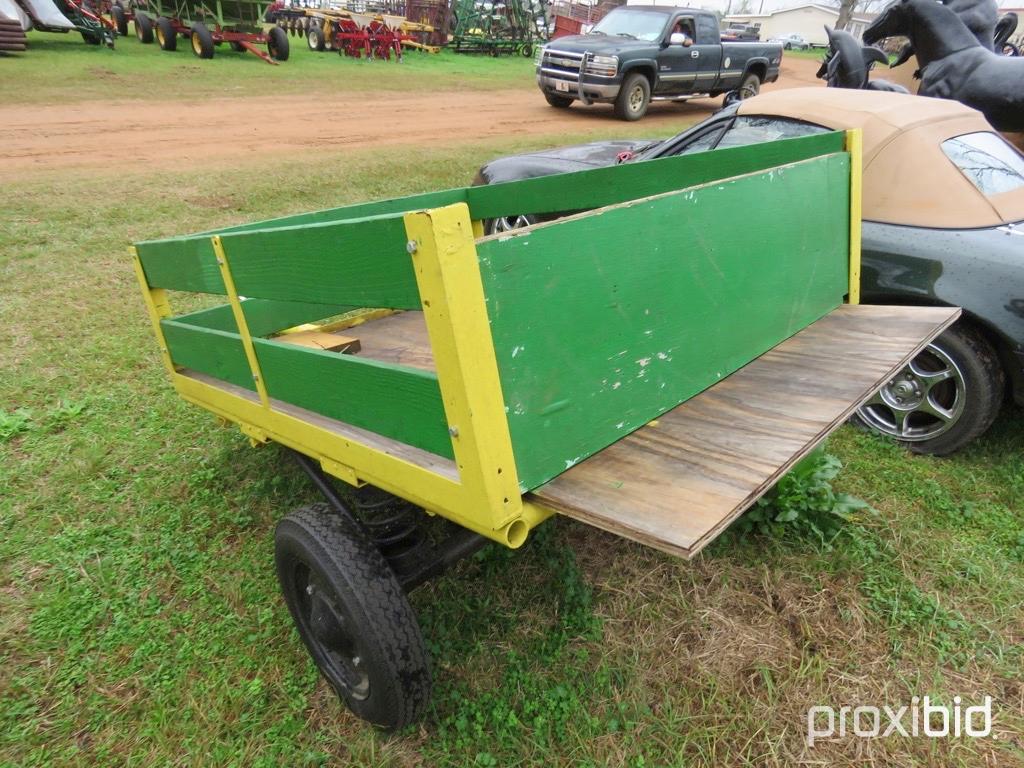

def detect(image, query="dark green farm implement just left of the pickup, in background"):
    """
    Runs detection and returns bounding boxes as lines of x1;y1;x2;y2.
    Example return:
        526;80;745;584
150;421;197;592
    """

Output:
452;0;550;56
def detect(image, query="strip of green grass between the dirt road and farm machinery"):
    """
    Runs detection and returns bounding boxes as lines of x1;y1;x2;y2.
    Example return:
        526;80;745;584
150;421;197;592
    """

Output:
0;25;537;103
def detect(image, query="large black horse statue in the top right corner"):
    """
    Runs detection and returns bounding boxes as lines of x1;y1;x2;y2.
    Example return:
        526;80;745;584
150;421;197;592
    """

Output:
863;0;1024;131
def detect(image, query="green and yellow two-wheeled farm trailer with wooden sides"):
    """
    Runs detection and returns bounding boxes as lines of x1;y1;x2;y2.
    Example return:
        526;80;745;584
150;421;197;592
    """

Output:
135;133;959;727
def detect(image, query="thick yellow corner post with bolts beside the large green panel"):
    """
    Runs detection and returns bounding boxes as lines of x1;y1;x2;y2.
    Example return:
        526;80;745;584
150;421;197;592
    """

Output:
406;203;522;528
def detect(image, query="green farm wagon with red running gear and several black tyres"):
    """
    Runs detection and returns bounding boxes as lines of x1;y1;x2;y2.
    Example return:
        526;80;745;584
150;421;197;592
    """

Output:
134;0;289;65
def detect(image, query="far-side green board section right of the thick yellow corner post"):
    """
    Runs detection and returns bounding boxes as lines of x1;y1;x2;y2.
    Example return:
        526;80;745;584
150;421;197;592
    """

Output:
467;132;845;219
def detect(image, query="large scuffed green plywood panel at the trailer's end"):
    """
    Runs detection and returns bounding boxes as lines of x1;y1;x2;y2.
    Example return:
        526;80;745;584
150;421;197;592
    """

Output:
477;155;849;490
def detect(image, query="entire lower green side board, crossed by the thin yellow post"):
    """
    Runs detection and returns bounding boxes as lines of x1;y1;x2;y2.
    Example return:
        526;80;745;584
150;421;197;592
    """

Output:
161;319;454;459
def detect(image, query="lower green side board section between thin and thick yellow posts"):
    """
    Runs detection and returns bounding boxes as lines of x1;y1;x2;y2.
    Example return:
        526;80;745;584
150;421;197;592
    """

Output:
253;339;454;459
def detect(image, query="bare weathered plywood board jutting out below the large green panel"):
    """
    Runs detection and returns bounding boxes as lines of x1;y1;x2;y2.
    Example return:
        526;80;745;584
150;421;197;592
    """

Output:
529;305;959;557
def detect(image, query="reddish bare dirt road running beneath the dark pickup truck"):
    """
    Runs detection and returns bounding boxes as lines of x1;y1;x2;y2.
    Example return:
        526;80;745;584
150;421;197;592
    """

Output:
0;58;821;179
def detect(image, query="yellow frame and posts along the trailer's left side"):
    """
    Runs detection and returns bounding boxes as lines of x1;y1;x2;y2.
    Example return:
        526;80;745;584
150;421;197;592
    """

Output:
132;203;552;548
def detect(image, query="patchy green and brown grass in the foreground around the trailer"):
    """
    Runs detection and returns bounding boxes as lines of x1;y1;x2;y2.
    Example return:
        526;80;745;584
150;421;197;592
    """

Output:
0;49;1024;766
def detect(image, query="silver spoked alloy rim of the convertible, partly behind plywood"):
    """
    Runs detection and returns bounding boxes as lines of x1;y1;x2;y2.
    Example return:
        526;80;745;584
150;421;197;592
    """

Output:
858;344;967;442
